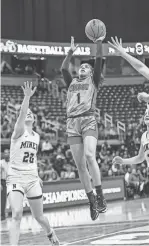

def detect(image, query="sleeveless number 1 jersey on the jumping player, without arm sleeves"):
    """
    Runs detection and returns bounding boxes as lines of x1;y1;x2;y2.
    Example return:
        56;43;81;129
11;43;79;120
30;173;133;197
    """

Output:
67;76;97;117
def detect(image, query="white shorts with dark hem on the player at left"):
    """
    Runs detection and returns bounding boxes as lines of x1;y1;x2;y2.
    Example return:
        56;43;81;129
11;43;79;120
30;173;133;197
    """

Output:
7;168;42;199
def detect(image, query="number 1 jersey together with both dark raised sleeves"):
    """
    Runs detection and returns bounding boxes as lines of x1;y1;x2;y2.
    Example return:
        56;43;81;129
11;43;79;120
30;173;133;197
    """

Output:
61;49;102;118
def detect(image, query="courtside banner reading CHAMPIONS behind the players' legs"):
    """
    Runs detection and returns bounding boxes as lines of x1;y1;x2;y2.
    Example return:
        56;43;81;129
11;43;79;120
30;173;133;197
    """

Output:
7;177;125;212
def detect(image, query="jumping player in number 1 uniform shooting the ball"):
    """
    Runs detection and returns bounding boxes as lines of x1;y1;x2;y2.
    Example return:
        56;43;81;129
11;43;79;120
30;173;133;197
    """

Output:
61;37;107;220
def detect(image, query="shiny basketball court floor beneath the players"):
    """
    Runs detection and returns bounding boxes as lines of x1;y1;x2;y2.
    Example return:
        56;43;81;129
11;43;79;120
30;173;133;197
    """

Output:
0;198;149;246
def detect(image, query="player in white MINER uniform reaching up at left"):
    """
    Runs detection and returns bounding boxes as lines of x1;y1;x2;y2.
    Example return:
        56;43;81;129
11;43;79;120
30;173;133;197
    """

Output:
7;82;59;245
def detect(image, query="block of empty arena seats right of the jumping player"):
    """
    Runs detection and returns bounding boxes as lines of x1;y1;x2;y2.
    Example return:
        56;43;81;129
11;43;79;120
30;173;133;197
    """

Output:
97;85;149;123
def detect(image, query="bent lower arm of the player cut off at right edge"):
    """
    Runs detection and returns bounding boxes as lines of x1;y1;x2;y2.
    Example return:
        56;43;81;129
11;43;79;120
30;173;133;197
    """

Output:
112;143;145;165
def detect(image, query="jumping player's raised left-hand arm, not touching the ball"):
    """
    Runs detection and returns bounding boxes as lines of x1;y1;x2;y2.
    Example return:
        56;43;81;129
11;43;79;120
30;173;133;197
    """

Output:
61;37;78;86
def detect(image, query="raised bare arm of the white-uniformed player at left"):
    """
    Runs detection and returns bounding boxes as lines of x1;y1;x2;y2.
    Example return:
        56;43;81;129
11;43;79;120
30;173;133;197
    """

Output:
12;81;36;139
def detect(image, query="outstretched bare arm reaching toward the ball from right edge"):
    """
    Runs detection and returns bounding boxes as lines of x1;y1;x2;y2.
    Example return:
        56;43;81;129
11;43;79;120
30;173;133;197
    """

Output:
108;37;149;80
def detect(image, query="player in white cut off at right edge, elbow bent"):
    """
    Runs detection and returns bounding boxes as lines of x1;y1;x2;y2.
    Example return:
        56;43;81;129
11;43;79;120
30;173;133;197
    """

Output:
113;104;149;179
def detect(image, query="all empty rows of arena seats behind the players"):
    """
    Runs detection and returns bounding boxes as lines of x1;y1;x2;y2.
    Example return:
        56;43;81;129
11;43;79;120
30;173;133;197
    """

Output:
1;85;149;123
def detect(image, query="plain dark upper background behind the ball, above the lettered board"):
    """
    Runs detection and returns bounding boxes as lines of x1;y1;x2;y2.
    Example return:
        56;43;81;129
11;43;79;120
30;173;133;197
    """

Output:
1;0;149;42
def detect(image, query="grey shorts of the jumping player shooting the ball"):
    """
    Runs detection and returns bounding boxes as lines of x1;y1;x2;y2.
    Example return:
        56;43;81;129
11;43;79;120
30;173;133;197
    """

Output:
66;116;98;145
